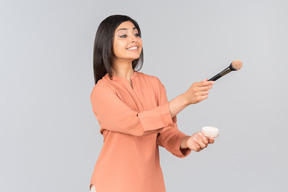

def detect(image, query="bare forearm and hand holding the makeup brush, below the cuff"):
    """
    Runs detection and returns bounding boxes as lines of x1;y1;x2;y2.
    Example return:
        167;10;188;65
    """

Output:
169;79;215;118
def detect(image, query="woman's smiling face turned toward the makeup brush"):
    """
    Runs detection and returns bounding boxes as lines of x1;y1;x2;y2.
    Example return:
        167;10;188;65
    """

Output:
113;21;142;62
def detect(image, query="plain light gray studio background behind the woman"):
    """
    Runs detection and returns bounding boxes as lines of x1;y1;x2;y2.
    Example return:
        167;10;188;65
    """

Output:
0;0;288;192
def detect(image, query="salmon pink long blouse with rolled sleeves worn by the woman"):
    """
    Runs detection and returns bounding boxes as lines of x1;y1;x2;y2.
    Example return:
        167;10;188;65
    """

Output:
90;71;191;192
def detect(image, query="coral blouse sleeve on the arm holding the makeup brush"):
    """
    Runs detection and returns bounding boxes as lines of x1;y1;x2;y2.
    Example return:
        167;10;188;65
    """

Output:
90;84;173;136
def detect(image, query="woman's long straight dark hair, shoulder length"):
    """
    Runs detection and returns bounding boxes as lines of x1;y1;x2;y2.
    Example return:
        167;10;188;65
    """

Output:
93;15;143;84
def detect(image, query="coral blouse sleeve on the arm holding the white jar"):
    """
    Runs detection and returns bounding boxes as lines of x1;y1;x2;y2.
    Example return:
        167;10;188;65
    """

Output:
157;82;191;158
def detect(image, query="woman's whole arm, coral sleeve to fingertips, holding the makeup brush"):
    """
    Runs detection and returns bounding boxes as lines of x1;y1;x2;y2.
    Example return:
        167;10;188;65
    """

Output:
90;80;213;136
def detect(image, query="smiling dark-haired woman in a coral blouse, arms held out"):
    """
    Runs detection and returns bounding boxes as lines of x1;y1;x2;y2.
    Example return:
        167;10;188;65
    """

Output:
90;15;214;192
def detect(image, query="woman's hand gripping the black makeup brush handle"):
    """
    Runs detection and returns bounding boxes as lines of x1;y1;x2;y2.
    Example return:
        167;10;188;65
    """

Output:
184;79;215;105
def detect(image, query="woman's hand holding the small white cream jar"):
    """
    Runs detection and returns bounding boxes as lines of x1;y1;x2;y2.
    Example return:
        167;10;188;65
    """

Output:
181;131;215;152
